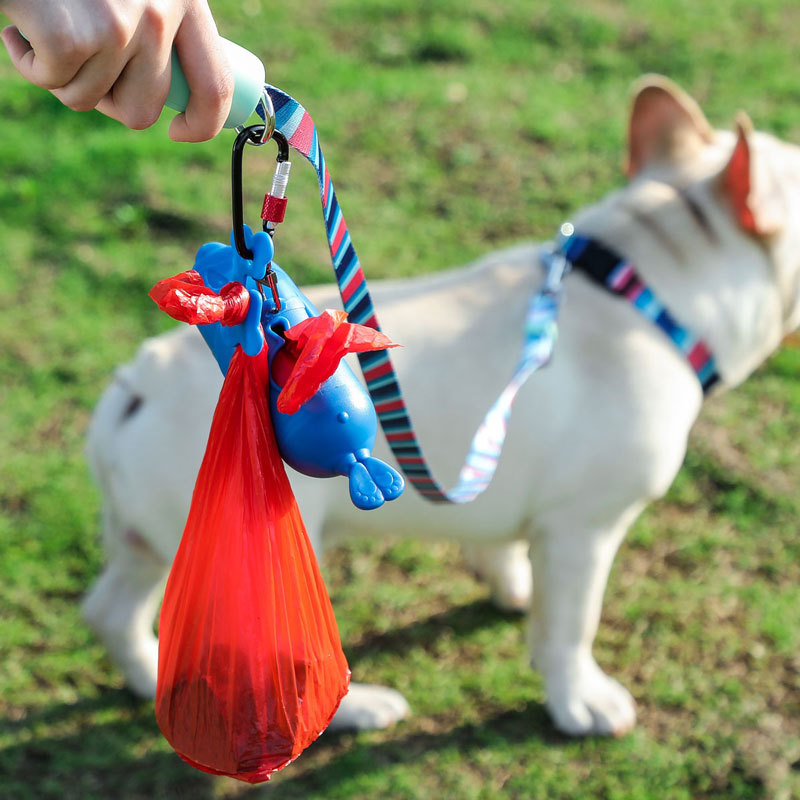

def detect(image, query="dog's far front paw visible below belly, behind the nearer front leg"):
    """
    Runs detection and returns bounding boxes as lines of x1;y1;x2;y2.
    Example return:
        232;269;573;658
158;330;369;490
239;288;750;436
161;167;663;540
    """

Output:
461;541;533;611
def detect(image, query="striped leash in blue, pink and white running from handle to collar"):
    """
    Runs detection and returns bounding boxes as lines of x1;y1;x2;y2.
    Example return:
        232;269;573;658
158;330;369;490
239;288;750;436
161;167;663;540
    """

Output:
257;85;572;503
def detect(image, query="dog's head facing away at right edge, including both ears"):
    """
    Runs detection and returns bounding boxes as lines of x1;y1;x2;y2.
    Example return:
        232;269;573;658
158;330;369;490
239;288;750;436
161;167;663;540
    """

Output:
625;75;800;333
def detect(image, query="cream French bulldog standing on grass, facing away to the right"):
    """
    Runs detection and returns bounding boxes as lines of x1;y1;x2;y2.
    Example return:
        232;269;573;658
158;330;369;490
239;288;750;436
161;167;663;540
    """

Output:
84;76;800;735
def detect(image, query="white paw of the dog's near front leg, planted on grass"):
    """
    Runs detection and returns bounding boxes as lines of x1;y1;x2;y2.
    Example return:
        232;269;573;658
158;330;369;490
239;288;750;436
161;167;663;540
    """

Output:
545;660;636;736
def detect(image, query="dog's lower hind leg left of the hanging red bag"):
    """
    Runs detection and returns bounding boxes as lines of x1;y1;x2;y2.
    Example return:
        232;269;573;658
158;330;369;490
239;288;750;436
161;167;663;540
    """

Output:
83;516;169;697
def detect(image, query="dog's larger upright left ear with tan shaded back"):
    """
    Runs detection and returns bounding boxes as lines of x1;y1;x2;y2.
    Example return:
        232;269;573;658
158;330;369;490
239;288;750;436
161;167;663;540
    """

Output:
625;75;714;178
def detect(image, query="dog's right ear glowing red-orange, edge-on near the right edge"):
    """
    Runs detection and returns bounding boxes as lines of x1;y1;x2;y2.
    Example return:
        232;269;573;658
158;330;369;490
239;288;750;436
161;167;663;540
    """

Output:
720;111;786;236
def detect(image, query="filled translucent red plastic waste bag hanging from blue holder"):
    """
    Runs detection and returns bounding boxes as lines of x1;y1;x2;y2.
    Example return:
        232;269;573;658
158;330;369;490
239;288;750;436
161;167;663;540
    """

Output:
156;347;350;783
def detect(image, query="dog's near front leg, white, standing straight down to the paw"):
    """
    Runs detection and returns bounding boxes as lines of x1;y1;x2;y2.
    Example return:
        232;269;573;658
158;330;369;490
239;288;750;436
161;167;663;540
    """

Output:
531;503;644;736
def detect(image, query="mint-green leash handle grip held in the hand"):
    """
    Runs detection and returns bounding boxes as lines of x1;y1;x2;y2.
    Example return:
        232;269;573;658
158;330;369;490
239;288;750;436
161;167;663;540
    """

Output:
166;38;265;128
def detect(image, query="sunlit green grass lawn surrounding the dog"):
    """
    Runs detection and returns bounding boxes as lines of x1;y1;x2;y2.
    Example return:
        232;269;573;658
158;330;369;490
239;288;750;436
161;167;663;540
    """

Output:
0;0;800;800
